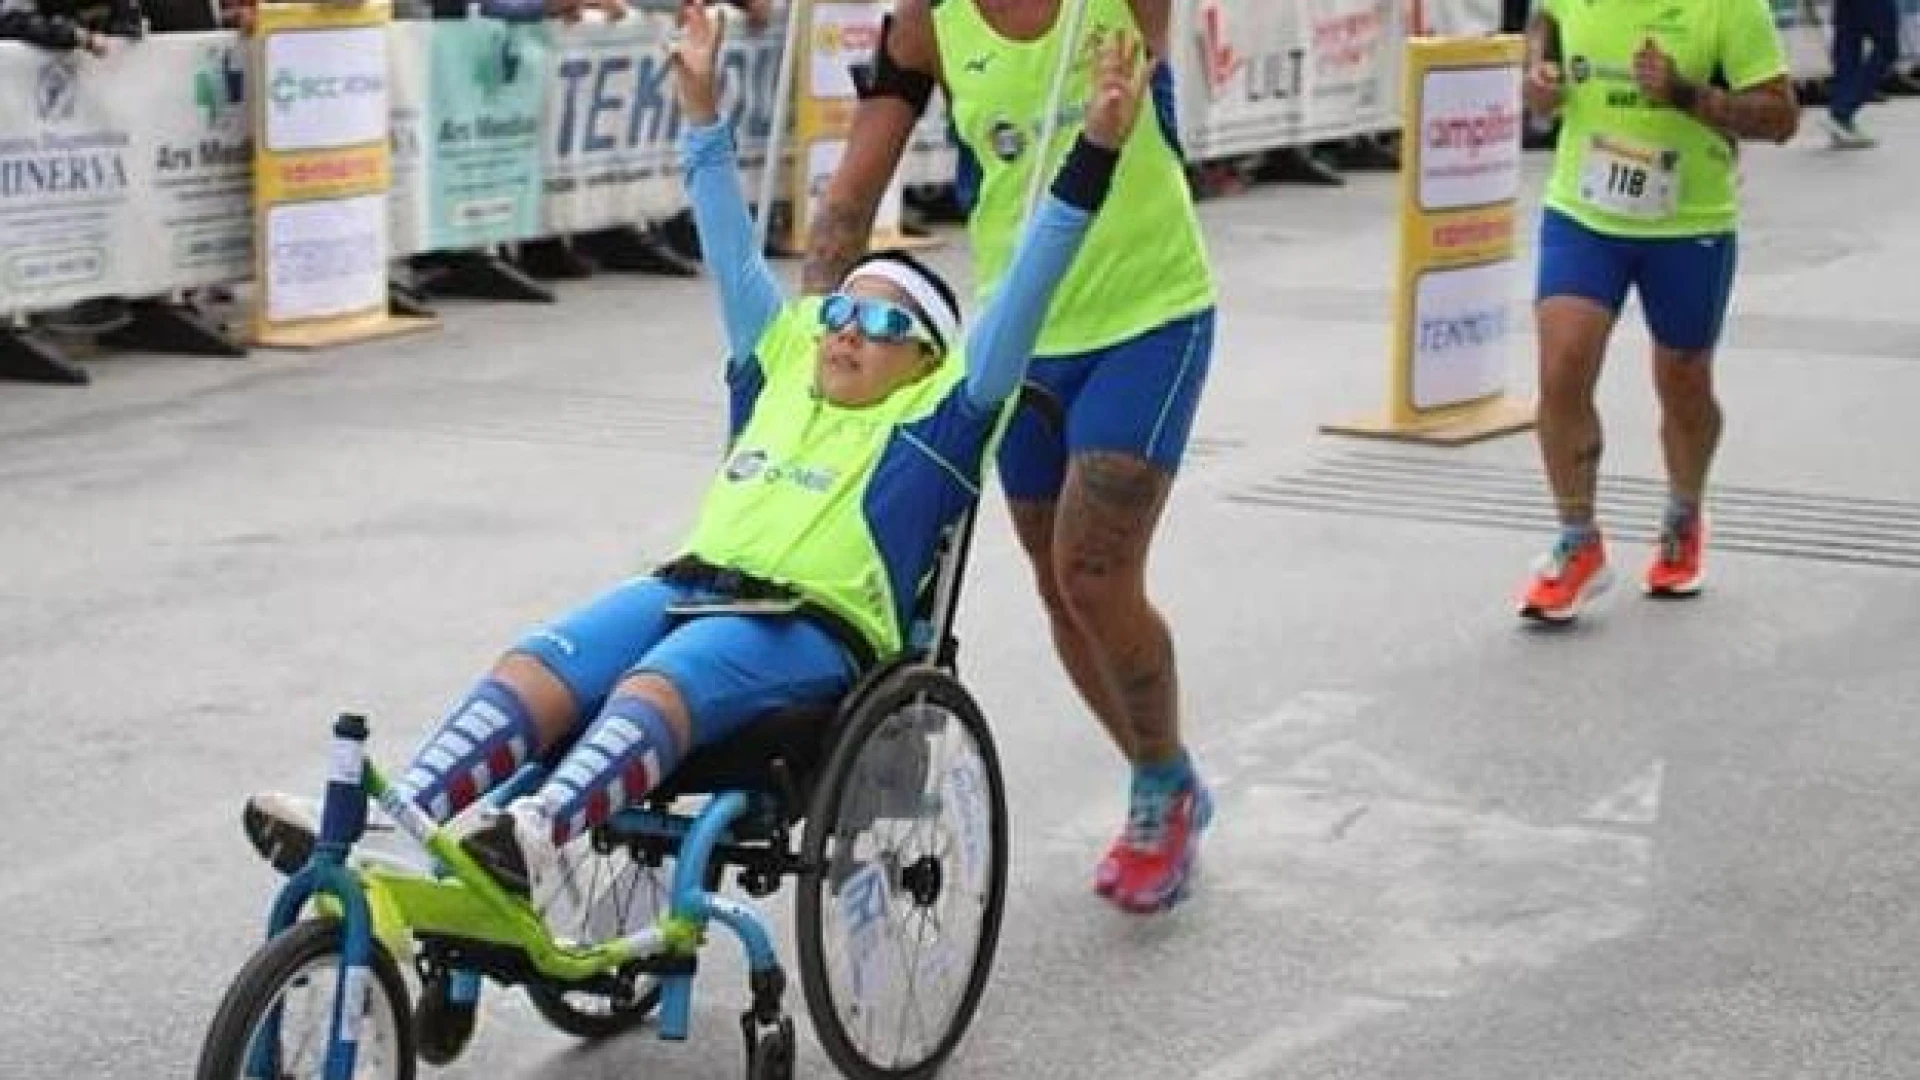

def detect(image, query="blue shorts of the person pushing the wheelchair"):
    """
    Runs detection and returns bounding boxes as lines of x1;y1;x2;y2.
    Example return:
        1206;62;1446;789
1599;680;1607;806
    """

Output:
998;307;1213;502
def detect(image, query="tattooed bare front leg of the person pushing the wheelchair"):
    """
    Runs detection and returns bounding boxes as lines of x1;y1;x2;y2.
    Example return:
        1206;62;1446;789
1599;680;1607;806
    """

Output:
1054;452;1181;765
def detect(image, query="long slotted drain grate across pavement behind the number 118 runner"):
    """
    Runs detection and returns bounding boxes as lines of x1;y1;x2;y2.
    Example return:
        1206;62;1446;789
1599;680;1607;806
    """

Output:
1227;452;1920;571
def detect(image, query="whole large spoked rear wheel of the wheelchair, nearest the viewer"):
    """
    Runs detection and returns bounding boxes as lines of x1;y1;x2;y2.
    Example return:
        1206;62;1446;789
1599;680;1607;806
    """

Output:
797;667;1006;1080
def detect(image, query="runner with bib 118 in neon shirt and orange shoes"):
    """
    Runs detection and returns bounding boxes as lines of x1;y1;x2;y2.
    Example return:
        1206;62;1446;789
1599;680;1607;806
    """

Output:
1521;0;1799;623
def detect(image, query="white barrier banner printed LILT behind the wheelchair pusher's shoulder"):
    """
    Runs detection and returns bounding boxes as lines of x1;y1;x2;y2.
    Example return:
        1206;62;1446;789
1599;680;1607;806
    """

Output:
1175;0;1405;161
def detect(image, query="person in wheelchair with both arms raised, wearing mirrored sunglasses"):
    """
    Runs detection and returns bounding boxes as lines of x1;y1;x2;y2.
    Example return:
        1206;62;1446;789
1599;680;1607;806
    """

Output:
244;0;1144;926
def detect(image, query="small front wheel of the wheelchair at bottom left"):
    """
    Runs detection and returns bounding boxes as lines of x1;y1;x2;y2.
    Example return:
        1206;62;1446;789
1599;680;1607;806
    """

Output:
194;919;415;1080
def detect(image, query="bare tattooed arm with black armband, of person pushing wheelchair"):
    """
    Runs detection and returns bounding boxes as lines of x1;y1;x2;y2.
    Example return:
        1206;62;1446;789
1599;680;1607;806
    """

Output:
801;0;941;292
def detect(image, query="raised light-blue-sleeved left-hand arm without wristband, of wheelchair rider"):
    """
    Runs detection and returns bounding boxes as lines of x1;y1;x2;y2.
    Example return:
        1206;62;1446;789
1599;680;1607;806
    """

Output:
672;0;783;363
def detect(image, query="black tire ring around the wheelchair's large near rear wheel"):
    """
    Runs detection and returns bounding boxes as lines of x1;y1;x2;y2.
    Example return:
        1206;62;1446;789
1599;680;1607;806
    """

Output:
795;667;1008;1080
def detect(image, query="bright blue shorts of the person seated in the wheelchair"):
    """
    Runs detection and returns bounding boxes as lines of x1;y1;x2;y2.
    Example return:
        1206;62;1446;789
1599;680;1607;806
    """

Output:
515;577;854;746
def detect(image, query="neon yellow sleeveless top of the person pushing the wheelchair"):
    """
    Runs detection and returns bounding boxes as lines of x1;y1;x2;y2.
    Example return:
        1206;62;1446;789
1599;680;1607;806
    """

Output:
933;0;1213;356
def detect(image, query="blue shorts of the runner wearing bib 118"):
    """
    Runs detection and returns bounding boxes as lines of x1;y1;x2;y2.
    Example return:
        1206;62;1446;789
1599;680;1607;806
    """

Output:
1534;208;1738;350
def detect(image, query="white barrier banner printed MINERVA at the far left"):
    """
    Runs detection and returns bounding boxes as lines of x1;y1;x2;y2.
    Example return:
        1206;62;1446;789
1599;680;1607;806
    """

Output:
0;35;253;313
